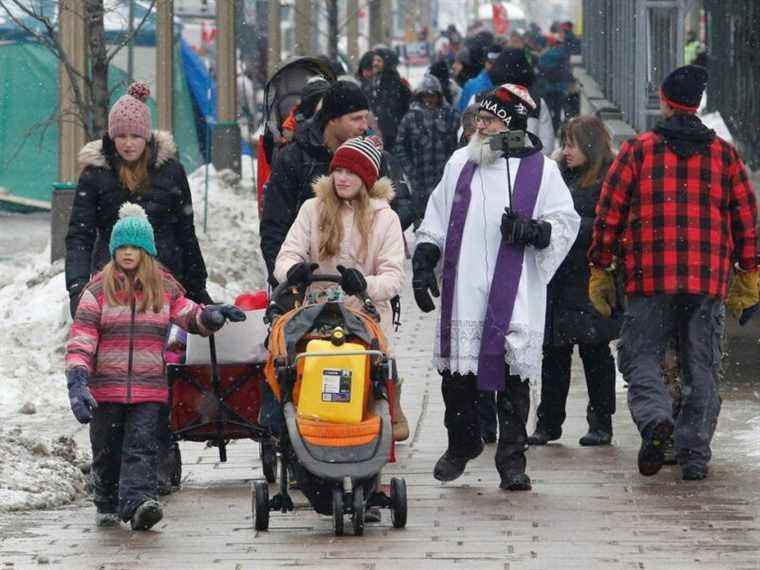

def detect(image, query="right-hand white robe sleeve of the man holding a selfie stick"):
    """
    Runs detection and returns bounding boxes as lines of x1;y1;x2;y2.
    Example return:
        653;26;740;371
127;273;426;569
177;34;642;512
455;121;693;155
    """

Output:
535;159;581;284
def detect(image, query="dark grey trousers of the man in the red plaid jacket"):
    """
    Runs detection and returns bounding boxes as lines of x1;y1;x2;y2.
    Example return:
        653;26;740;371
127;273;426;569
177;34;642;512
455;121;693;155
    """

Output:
618;294;725;466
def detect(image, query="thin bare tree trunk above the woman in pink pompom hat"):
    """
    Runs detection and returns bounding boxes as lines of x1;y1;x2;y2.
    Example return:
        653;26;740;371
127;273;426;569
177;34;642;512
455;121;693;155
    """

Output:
86;0;110;137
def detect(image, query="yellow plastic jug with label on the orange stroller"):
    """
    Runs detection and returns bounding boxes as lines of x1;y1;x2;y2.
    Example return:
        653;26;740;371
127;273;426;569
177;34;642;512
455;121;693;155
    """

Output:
298;339;369;424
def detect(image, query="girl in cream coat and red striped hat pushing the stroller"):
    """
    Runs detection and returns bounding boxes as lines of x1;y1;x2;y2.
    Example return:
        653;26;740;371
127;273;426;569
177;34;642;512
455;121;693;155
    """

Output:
274;137;409;441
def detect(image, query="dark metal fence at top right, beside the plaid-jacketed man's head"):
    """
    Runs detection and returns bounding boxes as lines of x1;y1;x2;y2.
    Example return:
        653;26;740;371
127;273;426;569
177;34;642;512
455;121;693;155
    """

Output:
705;0;760;168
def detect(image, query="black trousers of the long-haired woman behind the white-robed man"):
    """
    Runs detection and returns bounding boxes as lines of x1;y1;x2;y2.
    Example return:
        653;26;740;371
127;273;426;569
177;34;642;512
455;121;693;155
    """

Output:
538;342;615;433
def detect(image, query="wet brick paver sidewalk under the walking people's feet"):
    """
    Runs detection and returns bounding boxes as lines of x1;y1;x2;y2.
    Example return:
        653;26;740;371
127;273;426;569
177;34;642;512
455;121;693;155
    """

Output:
0;290;760;570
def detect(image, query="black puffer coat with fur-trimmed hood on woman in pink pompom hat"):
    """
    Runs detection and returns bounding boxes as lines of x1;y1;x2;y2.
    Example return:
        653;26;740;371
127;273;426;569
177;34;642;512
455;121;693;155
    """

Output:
66;131;211;303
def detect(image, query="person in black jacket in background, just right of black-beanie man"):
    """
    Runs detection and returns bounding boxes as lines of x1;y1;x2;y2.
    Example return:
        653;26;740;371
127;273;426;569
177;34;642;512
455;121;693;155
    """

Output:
367;47;412;153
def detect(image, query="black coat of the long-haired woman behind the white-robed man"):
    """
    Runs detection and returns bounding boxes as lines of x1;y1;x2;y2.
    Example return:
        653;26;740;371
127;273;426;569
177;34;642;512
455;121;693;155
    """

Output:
544;160;622;346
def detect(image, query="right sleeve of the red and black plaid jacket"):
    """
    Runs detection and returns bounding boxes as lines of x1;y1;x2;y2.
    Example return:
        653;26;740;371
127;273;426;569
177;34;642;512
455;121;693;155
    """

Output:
729;148;757;270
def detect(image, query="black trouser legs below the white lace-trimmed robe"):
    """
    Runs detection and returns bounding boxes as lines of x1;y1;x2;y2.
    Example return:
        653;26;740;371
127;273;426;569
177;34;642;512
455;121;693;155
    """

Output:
441;369;530;478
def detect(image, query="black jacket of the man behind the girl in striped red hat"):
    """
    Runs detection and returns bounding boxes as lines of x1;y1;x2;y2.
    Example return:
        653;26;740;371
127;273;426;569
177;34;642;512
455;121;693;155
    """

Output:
259;121;415;284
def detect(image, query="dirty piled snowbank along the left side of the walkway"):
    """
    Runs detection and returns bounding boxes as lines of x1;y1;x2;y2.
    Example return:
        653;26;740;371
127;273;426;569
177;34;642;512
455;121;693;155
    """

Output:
0;153;266;512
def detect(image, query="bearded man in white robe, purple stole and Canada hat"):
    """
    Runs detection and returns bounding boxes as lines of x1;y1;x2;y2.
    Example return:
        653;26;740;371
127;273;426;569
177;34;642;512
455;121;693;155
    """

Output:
412;84;580;490
